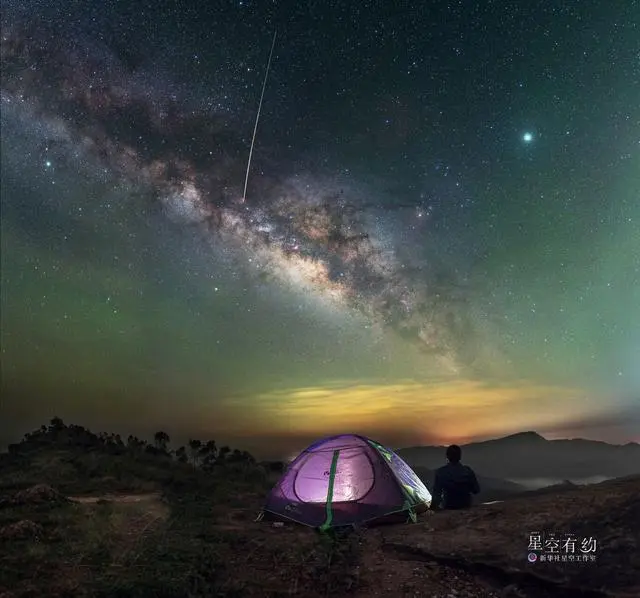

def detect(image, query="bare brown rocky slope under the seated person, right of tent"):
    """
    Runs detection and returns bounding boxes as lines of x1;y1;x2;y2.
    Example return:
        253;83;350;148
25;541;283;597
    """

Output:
380;476;640;598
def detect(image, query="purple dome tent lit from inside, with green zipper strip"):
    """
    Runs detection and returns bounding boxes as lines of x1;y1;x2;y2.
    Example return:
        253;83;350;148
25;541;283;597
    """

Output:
262;434;431;530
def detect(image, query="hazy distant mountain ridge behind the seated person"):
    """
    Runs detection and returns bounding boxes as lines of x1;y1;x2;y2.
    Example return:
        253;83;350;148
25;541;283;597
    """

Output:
397;432;640;482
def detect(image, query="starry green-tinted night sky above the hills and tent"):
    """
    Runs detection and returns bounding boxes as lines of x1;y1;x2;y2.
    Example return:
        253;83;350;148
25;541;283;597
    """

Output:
0;0;640;456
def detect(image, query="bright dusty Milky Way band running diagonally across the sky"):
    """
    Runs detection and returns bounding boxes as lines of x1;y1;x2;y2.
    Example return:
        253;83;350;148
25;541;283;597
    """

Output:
2;17;492;376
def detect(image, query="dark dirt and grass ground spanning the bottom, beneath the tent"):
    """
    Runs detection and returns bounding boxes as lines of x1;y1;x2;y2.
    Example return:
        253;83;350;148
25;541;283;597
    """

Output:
0;478;640;598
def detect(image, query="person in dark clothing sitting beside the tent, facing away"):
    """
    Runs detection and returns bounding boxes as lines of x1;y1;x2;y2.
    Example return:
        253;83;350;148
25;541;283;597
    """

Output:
431;444;480;509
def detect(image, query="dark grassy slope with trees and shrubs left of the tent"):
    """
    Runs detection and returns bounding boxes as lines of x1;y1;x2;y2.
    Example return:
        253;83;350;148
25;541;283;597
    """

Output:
0;422;358;598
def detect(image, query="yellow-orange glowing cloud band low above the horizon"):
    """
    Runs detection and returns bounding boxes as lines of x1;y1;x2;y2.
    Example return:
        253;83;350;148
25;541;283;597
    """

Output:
216;380;604;443
